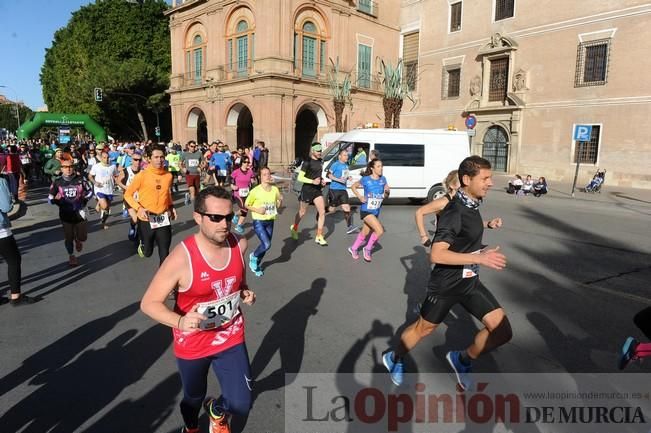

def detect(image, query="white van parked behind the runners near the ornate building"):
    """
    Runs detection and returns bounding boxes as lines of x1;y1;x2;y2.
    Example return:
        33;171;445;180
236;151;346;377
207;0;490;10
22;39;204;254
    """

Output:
323;129;469;202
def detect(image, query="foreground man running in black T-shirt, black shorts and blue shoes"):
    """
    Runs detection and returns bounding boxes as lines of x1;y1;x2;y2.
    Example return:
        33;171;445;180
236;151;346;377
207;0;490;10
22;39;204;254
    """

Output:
382;156;512;390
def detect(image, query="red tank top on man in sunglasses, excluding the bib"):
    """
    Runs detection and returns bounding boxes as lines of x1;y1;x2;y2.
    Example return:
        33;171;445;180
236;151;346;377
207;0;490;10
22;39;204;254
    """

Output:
173;234;245;359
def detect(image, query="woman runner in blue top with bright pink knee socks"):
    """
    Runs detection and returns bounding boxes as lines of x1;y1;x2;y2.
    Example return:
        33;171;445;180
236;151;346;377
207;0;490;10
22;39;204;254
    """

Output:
344;158;390;263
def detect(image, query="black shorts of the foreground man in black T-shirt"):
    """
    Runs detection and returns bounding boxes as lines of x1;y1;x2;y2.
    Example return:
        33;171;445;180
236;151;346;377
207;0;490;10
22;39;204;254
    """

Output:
420;278;501;324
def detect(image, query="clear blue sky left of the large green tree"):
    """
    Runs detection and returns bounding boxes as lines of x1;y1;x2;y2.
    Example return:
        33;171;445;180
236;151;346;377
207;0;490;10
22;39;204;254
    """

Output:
0;0;93;110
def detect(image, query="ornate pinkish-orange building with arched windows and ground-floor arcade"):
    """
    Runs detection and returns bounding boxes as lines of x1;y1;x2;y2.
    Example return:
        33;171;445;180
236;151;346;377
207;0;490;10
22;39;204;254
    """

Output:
167;0;400;166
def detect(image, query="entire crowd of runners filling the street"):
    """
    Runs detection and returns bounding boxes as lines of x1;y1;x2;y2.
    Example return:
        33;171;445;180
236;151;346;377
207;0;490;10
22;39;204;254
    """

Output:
0;136;649;433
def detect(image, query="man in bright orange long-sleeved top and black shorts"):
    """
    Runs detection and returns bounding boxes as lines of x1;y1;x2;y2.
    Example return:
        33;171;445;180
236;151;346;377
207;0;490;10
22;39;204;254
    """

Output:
124;144;176;264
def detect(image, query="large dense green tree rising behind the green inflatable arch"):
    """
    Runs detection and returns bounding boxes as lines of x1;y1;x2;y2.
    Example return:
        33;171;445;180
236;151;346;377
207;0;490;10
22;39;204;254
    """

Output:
41;0;171;139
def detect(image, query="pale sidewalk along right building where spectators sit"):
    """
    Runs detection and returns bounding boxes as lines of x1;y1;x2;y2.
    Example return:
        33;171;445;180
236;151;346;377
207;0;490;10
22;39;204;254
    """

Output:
491;175;651;208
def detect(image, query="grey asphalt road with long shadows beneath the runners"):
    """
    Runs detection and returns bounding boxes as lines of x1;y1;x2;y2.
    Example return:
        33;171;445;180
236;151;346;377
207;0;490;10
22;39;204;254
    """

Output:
0;180;651;433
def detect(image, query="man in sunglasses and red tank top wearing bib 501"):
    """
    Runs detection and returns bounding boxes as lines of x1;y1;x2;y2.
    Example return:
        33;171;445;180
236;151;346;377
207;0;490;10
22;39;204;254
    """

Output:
140;186;255;433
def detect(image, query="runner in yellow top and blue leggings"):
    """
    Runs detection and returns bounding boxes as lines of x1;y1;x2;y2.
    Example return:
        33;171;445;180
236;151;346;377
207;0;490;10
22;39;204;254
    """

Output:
245;167;283;277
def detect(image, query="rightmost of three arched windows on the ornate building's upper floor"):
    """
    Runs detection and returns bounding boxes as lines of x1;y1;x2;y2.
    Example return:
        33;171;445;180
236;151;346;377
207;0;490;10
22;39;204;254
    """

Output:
294;21;327;77
